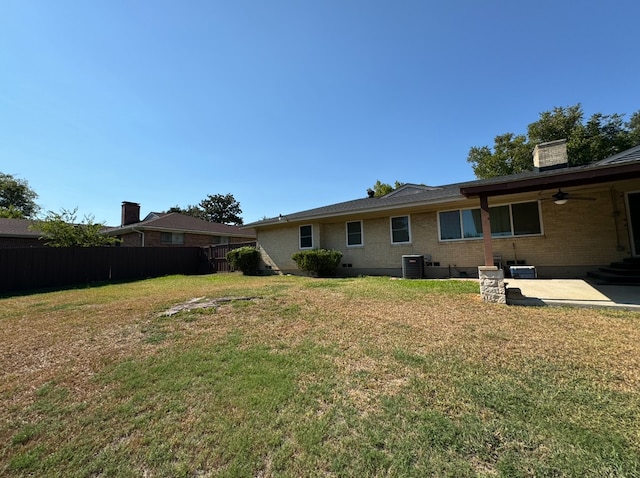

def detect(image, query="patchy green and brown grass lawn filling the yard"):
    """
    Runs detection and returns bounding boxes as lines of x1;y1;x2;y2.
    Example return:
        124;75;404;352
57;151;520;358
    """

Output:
0;274;640;477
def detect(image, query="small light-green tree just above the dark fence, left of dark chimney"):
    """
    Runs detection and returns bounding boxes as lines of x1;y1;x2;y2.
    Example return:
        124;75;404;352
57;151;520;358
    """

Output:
31;208;118;247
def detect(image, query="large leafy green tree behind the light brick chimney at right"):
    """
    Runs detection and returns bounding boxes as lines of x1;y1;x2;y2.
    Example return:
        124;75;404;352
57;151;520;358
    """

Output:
467;104;640;179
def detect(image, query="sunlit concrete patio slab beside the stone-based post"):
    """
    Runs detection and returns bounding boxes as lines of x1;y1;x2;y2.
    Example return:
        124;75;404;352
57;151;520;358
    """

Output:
504;278;640;311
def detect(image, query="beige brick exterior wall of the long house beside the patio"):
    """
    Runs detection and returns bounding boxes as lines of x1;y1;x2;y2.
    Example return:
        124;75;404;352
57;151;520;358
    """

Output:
258;181;640;280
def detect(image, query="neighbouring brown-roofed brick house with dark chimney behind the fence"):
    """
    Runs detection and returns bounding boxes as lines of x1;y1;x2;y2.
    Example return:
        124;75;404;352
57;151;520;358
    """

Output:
107;201;255;247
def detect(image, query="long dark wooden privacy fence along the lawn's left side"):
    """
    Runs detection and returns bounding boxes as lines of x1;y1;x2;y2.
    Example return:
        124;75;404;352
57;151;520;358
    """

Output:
0;247;214;292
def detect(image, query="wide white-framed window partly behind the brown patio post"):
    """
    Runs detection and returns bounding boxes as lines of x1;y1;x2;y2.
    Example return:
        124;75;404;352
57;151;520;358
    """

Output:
438;201;542;241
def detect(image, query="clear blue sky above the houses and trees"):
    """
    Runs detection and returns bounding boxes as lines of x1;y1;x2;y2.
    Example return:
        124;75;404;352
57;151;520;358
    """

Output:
0;0;640;225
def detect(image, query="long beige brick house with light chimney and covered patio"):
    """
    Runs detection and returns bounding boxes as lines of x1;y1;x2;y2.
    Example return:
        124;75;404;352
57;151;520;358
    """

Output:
246;140;640;278
